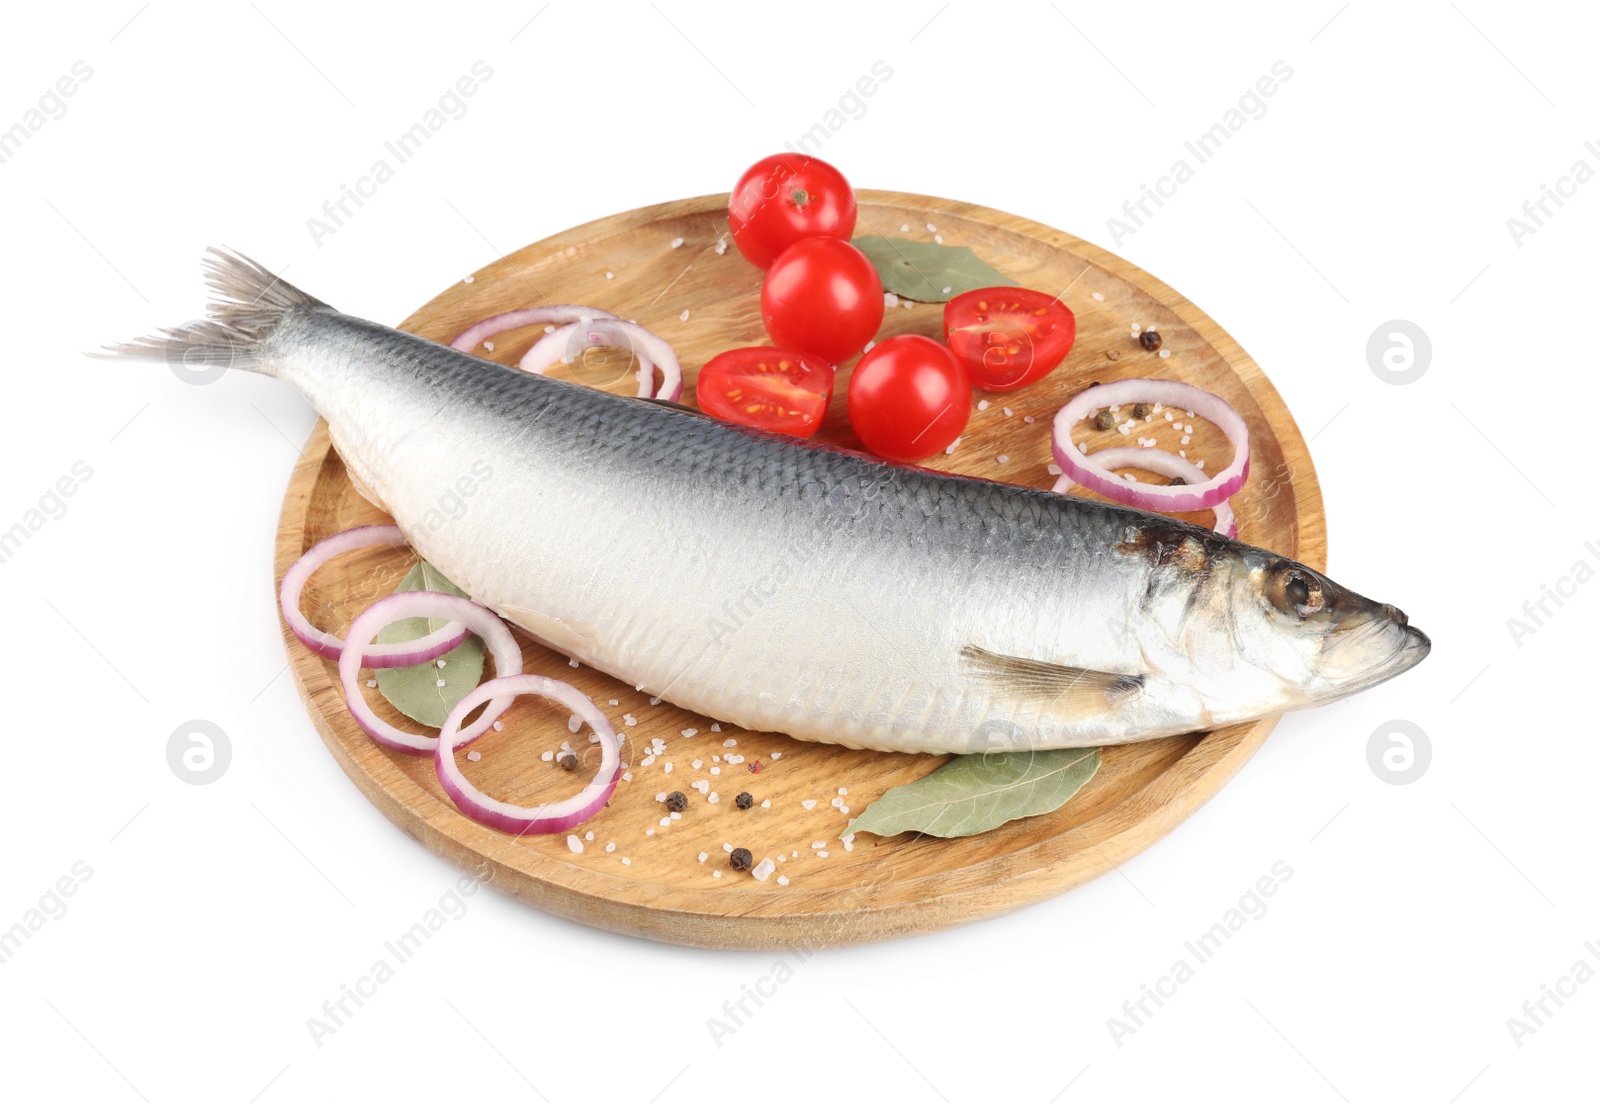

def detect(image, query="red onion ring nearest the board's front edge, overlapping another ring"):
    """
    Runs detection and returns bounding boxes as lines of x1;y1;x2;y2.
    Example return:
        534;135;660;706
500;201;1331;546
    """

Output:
434;673;622;835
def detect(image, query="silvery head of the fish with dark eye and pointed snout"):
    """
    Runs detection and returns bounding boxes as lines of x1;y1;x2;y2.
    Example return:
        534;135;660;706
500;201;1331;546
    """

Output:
1229;547;1432;707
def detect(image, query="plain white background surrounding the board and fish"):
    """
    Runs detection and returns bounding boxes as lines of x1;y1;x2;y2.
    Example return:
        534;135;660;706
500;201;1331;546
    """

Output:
0;0;1600;1105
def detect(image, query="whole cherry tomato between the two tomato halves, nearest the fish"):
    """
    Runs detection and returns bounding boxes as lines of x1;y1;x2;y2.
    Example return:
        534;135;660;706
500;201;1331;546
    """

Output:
848;334;973;461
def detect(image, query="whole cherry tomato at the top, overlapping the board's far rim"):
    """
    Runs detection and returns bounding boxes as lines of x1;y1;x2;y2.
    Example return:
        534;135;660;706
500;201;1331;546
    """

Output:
728;154;856;269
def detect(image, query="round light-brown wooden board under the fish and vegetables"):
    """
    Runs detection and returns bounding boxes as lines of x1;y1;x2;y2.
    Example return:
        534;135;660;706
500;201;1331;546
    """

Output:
277;192;1326;949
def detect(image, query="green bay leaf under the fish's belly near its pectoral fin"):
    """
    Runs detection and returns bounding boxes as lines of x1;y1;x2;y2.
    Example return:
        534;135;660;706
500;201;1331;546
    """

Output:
845;749;1099;838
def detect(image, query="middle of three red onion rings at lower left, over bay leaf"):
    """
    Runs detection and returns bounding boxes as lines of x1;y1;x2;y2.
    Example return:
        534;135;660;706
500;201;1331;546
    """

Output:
339;592;522;753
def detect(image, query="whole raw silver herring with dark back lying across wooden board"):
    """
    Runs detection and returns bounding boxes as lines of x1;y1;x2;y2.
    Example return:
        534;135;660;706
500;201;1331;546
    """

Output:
106;250;1430;753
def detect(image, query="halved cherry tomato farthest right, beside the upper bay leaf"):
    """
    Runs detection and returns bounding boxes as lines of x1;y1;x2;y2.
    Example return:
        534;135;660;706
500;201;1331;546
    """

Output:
944;288;1078;392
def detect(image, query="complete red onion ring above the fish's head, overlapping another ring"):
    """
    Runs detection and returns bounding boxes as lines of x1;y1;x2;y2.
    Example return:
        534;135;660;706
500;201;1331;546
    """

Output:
1050;378;1250;512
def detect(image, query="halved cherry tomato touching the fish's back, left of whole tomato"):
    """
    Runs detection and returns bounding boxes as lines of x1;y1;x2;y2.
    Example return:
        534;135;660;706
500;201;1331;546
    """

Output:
694;346;834;438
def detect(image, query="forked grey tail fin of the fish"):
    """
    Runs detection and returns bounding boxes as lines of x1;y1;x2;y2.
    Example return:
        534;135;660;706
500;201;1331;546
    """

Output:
90;246;328;373
